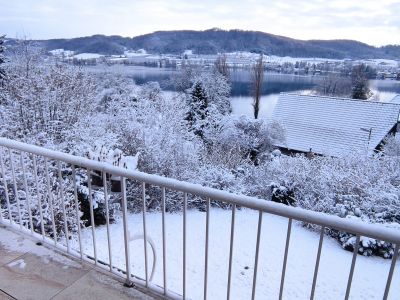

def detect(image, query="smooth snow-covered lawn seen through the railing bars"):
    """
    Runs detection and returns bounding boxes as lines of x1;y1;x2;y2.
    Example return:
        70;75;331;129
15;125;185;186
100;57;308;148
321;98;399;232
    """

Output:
70;209;400;299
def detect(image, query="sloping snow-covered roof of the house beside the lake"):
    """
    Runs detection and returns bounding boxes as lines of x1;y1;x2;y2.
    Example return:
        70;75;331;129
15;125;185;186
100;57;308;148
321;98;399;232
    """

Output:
272;93;400;156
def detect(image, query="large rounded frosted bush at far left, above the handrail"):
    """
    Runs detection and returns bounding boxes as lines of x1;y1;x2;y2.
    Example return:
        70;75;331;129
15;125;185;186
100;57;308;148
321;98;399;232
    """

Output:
2;54;96;145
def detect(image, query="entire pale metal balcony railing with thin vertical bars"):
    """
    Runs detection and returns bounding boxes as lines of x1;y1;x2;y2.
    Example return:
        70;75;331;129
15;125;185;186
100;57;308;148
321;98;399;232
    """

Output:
0;138;400;300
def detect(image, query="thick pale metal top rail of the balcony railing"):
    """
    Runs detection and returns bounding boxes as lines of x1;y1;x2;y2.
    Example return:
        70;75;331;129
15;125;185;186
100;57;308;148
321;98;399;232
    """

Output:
0;138;400;244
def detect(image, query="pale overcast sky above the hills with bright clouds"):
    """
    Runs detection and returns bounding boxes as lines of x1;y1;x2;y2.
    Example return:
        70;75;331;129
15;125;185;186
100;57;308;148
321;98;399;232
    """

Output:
0;0;400;46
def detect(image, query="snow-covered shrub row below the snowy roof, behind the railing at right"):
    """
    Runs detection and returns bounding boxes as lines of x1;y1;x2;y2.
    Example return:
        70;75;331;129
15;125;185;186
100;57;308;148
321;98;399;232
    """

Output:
245;153;400;257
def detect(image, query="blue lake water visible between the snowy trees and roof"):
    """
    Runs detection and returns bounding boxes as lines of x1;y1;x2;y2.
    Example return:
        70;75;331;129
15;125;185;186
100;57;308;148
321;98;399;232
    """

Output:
91;65;400;118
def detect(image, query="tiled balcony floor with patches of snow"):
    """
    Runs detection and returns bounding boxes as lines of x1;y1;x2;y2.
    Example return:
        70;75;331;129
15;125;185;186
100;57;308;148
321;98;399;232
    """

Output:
0;226;154;300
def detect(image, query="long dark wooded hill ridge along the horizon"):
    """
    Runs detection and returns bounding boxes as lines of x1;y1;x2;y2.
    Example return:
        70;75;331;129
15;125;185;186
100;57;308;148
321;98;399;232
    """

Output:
33;29;400;59
